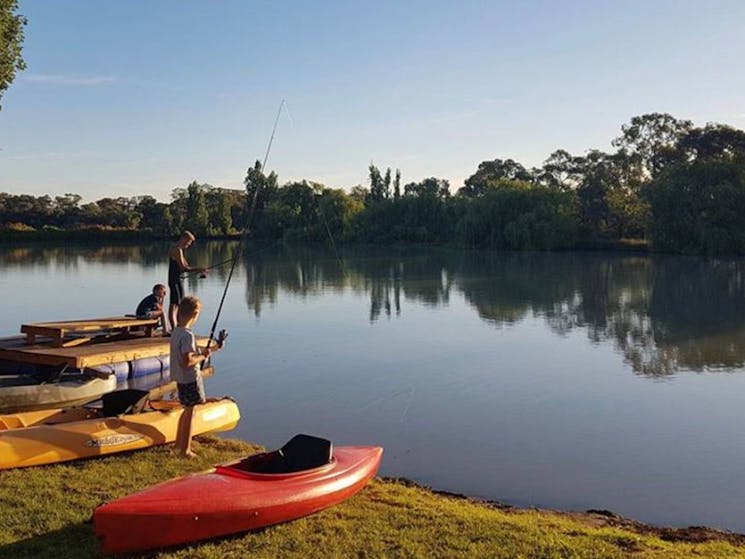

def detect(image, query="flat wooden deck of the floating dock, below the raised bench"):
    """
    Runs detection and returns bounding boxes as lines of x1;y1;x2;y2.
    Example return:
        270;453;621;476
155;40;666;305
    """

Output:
0;335;208;369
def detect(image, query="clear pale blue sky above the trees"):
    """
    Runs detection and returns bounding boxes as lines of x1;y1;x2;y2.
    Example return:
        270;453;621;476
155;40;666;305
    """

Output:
0;0;745;201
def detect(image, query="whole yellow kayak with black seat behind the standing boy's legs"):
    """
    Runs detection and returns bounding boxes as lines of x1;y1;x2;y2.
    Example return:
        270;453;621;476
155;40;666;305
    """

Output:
0;391;240;470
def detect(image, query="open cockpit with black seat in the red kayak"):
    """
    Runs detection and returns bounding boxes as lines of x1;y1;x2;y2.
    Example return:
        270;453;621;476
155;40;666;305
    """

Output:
216;434;334;477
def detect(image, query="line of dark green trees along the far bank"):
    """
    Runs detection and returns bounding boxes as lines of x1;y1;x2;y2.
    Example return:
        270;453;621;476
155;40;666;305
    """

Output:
0;113;745;254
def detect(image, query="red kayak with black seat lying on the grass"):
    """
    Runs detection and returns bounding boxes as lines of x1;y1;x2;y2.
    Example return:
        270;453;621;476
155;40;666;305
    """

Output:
93;435;383;553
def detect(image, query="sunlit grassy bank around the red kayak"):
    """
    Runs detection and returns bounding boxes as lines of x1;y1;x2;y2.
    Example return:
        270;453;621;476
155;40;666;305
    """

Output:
0;438;745;559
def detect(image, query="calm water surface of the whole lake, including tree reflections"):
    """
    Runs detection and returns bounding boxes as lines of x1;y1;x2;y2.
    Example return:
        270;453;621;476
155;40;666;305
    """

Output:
0;243;745;531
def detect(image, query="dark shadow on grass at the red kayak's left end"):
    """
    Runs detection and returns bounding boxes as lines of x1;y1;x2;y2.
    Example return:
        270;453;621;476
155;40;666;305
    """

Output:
0;522;101;559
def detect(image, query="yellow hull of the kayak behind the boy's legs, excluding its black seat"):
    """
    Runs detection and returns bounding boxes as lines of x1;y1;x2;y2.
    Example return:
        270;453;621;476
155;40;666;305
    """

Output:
0;399;240;470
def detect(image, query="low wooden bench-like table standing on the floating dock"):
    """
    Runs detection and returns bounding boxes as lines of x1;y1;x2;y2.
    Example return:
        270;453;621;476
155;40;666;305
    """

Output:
21;316;160;347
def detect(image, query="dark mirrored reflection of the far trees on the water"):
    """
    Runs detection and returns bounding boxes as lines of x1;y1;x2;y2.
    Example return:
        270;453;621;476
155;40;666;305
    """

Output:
0;241;745;377
